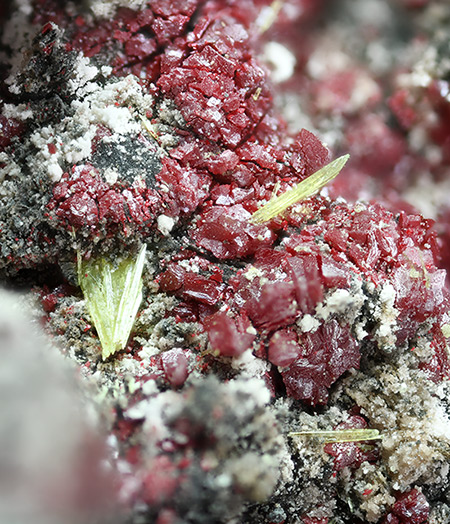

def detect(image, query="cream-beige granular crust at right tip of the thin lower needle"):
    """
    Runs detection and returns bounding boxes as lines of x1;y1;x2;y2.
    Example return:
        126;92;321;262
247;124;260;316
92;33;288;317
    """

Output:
346;362;450;491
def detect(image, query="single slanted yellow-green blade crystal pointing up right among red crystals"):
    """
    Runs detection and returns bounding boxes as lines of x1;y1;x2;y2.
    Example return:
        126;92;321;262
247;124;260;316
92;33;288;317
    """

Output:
250;155;350;224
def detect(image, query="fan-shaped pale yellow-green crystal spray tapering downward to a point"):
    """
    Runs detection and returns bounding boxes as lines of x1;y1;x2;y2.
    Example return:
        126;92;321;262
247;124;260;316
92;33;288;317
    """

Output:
78;244;146;360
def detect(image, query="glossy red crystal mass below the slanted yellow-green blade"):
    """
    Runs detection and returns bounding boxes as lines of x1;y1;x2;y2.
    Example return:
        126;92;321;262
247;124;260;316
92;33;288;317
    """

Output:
154;196;449;404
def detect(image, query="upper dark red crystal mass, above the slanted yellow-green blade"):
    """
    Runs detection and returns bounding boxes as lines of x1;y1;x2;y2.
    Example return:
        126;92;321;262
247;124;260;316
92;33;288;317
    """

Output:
34;2;329;247
